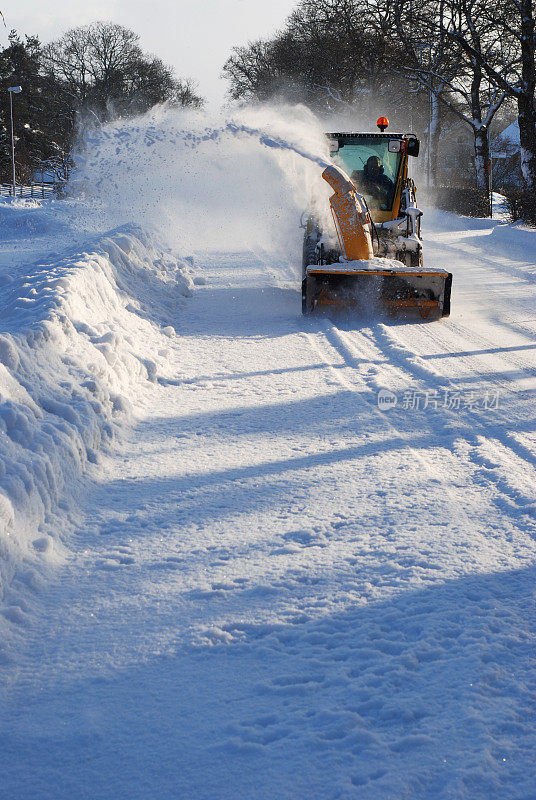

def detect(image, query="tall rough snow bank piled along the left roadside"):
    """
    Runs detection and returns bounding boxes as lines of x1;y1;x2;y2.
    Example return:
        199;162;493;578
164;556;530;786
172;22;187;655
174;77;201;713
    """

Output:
0;204;193;621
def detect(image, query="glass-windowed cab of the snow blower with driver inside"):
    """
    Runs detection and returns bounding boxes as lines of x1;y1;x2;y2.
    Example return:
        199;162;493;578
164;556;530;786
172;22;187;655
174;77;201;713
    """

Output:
326;133;419;222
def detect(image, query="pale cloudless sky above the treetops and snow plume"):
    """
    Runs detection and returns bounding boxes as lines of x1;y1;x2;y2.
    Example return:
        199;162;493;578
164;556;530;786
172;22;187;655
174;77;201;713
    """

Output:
0;0;298;107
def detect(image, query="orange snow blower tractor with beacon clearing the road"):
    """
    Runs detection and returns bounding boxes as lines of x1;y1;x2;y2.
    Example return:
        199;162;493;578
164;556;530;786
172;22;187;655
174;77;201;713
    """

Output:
302;117;452;320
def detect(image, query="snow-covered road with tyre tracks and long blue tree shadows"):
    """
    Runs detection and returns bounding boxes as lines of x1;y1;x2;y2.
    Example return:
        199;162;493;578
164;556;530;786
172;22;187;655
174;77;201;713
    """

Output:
0;208;536;800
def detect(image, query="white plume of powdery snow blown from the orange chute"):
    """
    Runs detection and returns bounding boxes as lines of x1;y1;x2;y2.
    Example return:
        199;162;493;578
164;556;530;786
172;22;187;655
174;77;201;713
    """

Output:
70;106;336;255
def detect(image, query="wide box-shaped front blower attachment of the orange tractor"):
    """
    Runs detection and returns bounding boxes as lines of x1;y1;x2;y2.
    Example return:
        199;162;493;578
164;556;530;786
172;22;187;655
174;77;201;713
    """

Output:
302;259;452;319
